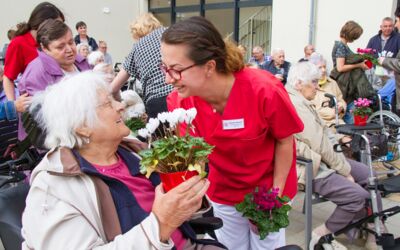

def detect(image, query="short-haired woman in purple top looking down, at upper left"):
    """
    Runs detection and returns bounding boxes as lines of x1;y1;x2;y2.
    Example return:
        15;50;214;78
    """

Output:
18;19;90;140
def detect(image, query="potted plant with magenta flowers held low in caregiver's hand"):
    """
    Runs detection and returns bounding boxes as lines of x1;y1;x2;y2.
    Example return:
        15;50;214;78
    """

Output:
235;187;291;240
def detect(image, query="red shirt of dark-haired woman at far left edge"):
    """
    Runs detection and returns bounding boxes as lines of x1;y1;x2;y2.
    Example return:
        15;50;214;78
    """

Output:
4;32;38;81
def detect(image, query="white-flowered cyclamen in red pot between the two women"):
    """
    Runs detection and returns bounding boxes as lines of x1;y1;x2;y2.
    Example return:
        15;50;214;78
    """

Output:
138;108;213;191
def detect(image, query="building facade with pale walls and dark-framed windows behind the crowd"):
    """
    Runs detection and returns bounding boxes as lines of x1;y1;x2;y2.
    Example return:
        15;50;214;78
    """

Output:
0;0;398;65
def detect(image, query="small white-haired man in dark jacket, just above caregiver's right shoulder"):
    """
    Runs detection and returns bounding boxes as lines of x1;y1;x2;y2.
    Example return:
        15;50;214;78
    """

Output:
262;49;290;84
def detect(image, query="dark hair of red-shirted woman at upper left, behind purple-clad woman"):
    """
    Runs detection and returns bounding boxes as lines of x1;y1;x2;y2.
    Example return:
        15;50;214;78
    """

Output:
15;2;65;36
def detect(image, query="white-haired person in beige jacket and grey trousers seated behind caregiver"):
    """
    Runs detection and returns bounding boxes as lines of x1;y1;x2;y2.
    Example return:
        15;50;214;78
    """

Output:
286;62;382;249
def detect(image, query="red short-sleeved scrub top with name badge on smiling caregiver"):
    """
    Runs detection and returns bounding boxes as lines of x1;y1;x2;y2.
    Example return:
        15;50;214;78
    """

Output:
167;68;303;205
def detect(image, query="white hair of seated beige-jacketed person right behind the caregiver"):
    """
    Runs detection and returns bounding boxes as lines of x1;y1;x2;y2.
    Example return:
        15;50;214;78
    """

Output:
287;62;321;88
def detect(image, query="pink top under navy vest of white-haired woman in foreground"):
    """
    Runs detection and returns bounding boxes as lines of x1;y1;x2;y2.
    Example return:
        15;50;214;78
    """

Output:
92;157;186;250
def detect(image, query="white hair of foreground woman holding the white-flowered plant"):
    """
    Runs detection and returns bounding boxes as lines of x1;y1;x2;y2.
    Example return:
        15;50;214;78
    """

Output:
29;71;111;148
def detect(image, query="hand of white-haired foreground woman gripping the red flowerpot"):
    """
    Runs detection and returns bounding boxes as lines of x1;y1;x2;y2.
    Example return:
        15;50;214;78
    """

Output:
152;176;210;241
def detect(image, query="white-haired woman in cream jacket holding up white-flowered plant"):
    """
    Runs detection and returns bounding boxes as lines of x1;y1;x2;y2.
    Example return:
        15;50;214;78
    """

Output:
22;72;227;249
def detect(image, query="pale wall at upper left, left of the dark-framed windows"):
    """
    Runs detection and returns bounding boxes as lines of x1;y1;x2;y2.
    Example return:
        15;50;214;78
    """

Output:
0;0;148;62
